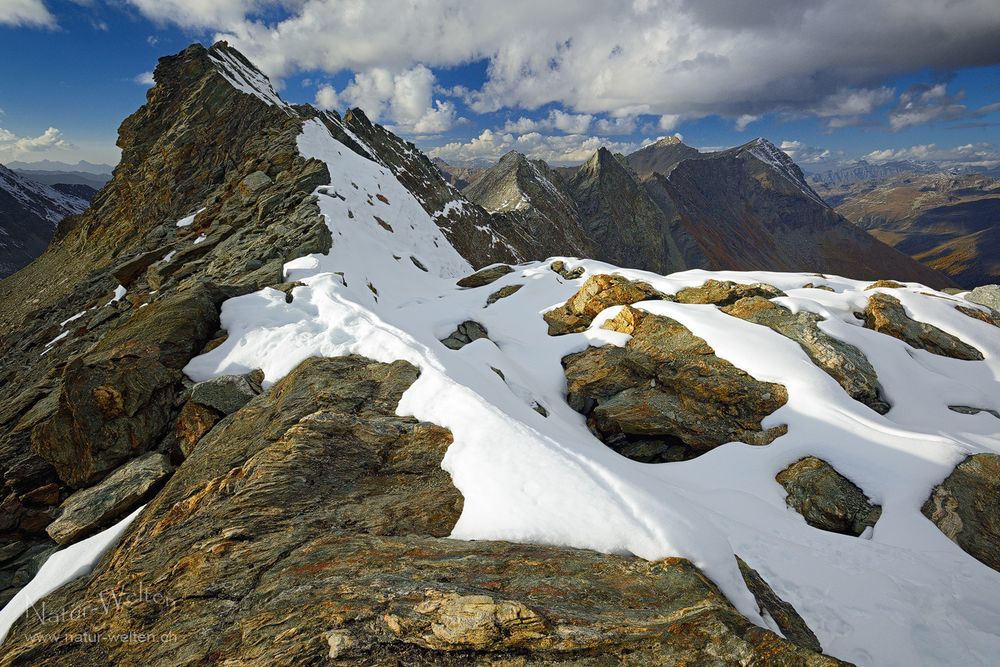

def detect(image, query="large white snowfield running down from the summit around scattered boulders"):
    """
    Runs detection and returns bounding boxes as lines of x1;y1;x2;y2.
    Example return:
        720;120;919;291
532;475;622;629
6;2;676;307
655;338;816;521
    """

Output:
172;121;1000;665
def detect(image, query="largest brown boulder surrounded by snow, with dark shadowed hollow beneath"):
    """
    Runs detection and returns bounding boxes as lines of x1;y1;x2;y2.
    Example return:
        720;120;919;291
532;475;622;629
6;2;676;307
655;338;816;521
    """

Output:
563;306;788;461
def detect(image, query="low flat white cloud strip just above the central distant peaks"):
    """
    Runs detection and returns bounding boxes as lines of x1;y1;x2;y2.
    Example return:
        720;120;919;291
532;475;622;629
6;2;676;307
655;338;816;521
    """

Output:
429;129;651;165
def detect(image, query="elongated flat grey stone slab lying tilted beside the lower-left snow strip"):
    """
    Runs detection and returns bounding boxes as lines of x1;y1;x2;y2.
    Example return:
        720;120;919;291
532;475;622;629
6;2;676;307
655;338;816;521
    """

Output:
46;452;174;546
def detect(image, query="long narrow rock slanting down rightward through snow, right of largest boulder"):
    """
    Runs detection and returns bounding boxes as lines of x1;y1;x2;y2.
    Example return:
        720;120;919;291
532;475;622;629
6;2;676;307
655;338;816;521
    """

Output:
722;296;889;415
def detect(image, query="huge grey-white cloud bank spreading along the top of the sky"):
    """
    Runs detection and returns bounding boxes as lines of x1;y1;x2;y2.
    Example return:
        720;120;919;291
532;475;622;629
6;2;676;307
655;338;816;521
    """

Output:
130;0;1000;123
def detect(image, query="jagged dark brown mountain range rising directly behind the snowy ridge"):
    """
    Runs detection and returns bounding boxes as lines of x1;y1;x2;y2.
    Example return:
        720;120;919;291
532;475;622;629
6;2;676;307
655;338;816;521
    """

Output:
436;137;953;287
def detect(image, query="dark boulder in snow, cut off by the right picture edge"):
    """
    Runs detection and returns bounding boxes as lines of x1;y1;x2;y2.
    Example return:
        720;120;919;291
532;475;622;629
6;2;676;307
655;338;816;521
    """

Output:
922;454;1000;572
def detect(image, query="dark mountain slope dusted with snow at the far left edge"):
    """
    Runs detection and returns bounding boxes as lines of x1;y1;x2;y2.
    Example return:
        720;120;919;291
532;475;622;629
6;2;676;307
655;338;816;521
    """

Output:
0;165;96;278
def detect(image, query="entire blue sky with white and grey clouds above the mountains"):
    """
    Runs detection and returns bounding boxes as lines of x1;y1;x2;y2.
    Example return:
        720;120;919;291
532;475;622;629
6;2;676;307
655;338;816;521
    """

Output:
0;0;1000;170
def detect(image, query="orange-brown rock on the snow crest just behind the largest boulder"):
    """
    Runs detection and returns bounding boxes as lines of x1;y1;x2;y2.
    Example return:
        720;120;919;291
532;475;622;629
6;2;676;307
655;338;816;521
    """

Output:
542;273;668;336
